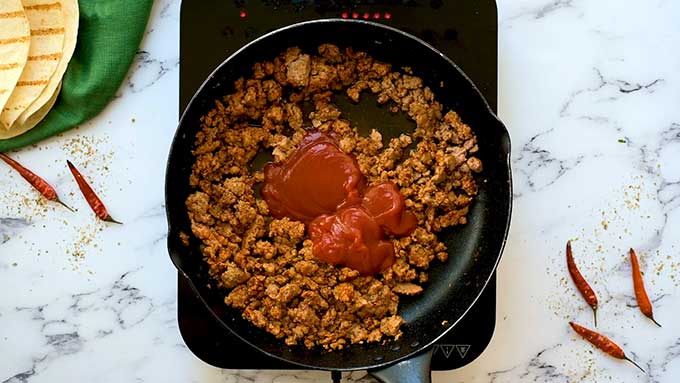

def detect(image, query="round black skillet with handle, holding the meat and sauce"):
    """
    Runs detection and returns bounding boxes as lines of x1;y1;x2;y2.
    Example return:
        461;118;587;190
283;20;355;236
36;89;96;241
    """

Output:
165;19;512;382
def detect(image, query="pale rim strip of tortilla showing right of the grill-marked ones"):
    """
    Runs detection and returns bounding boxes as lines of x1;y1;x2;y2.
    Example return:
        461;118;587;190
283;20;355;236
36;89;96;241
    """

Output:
18;0;79;124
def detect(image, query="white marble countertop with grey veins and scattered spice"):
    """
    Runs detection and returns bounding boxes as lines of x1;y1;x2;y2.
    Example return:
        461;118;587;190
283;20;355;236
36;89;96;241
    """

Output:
0;0;680;383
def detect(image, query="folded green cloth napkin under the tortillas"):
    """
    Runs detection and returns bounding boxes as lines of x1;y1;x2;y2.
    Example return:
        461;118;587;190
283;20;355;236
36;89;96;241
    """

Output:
0;0;153;152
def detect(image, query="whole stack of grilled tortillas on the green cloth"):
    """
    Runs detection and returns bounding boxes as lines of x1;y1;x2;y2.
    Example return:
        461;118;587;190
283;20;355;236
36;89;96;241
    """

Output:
0;0;78;139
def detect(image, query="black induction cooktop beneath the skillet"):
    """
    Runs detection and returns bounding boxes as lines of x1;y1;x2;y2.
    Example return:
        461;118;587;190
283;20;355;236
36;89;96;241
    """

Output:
178;0;498;370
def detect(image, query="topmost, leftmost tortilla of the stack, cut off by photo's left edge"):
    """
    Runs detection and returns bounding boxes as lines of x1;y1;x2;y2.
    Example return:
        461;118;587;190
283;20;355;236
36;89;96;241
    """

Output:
0;0;31;116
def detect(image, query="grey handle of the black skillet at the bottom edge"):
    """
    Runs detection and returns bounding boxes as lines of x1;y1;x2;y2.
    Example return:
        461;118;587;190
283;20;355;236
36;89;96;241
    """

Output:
368;347;434;383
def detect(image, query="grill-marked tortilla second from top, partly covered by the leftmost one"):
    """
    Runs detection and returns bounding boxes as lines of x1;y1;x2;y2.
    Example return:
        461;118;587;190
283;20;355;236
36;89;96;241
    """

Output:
0;0;65;129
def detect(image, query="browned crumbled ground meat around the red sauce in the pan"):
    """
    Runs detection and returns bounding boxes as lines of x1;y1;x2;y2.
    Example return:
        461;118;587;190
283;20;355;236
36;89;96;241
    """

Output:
186;44;482;349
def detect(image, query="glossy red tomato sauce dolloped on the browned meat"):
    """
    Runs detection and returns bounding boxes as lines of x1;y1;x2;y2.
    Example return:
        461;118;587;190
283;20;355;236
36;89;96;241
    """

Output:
262;132;417;275
